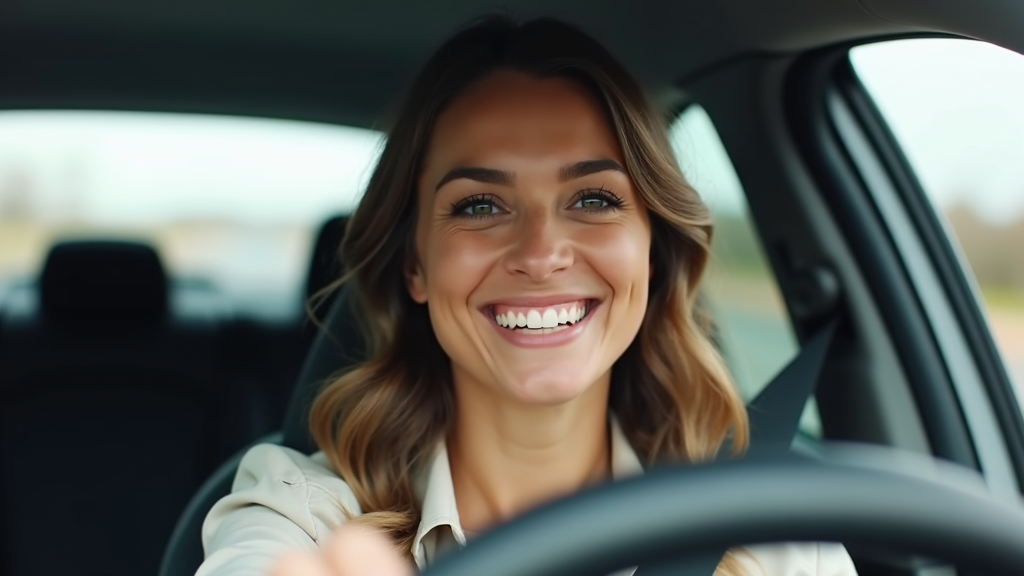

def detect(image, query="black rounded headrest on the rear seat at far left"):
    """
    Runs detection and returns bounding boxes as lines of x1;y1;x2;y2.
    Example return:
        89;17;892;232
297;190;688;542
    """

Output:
39;241;167;330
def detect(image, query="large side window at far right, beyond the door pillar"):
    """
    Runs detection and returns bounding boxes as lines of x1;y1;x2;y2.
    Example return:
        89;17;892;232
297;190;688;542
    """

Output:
850;38;1024;416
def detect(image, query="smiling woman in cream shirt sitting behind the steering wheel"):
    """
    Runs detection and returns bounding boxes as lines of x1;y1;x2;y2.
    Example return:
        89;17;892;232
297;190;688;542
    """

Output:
200;14;854;576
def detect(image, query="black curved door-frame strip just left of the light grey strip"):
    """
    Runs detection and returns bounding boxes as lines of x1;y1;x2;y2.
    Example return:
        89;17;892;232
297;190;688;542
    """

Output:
785;46;979;469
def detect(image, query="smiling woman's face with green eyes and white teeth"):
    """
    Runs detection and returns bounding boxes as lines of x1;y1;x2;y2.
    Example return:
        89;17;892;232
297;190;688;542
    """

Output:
409;72;651;405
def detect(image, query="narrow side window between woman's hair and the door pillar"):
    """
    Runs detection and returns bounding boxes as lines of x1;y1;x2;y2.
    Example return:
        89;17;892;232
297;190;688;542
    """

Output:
670;105;821;438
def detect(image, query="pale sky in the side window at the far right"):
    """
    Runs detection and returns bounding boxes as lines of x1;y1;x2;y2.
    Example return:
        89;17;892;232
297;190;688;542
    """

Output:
851;39;1024;223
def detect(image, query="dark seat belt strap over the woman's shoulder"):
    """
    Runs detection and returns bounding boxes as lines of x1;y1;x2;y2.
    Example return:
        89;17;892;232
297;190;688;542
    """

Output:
633;319;839;576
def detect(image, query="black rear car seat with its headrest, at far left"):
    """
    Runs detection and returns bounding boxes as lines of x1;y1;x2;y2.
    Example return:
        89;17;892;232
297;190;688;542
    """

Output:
0;241;260;576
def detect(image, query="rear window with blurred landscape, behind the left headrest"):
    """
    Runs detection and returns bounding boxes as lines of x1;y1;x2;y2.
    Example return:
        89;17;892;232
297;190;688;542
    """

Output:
0;111;381;314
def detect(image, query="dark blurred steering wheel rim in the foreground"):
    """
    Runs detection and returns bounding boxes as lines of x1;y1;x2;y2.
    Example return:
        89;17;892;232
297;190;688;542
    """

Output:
423;448;1024;576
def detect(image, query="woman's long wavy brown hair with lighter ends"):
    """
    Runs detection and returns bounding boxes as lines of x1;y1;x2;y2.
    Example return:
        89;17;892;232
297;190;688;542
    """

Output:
310;16;748;573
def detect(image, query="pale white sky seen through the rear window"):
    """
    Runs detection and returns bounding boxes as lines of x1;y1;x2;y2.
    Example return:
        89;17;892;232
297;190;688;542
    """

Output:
0;112;383;224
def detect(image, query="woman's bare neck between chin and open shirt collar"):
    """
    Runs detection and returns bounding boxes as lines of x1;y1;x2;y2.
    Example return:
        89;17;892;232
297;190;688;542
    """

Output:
449;368;610;532
